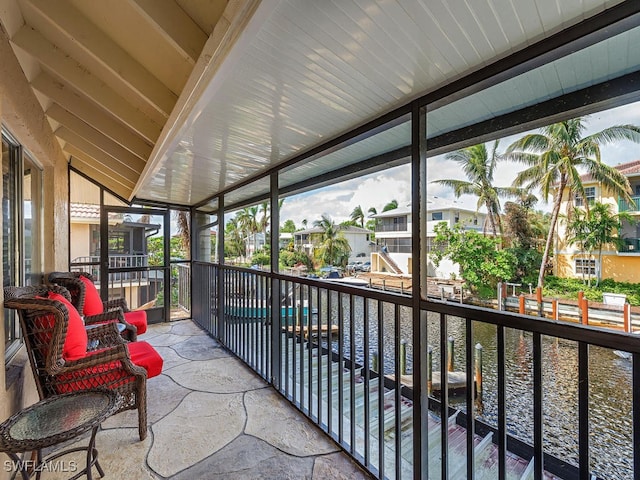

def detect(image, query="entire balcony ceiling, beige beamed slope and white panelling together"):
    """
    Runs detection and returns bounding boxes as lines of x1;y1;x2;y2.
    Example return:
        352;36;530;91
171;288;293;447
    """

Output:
2;0;640;205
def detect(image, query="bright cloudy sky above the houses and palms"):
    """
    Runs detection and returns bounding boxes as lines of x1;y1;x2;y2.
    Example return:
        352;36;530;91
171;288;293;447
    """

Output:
280;103;640;228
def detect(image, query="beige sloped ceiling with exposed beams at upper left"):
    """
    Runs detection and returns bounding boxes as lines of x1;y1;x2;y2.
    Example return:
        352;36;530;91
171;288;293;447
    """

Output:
2;0;235;198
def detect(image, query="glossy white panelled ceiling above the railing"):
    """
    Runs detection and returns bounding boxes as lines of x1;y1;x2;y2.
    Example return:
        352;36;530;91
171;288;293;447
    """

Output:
135;0;629;204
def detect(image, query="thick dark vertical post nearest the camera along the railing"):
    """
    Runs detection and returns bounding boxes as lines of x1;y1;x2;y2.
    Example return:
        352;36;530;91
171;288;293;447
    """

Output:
411;102;429;478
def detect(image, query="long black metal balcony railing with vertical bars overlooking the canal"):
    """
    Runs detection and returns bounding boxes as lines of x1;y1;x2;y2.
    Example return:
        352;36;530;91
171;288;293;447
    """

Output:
193;262;640;479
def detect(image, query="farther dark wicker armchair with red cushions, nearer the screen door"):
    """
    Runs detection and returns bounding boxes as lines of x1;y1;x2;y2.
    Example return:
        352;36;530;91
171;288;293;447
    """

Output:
49;272;147;342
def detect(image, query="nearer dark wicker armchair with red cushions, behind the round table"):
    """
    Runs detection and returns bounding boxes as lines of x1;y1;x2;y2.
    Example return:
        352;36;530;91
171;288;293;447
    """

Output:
4;285;162;440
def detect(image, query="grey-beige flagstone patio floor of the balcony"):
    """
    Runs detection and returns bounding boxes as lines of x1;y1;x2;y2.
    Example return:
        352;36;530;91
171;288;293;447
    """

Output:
42;320;372;480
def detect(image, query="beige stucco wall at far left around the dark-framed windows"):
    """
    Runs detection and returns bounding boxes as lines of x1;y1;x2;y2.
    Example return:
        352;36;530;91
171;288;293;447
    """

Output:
0;21;69;450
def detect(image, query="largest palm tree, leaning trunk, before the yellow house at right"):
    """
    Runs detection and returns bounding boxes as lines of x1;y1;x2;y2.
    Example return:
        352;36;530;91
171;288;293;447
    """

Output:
505;117;640;287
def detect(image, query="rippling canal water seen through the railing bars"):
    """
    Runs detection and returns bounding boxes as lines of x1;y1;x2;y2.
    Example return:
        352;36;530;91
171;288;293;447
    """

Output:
323;299;633;479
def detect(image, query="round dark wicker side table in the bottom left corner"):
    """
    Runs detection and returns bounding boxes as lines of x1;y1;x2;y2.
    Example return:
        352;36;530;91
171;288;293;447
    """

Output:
0;390;122;480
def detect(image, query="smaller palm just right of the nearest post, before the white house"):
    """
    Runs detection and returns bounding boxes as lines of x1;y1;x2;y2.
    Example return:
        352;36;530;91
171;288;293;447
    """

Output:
432;140;522;236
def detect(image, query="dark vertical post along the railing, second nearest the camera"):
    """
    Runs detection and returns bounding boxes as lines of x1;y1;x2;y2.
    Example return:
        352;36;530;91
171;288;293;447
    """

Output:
270;172;280;390
